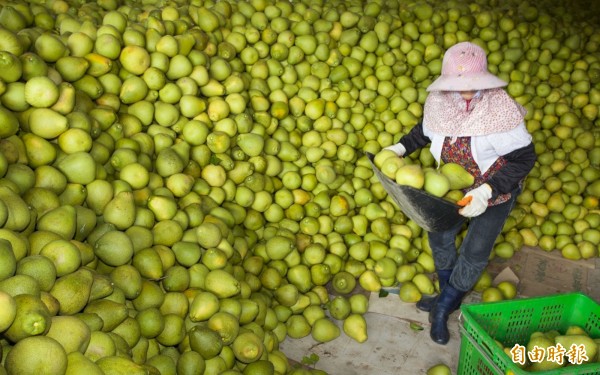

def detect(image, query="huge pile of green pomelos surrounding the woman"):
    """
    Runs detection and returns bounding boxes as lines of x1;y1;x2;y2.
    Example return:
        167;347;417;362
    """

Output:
0;0;600;375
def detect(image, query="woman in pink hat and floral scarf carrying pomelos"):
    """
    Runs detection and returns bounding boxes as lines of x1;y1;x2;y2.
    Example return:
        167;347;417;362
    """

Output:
386;42;536;345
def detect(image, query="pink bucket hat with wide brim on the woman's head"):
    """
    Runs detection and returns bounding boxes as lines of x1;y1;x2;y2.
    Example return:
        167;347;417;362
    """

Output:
427;42;508;91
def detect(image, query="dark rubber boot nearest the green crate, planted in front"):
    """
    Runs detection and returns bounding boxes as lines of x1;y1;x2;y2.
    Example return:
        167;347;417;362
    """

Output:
429;284;467;345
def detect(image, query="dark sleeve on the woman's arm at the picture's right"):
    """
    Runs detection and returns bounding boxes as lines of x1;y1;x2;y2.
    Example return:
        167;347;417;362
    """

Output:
487;142;537;198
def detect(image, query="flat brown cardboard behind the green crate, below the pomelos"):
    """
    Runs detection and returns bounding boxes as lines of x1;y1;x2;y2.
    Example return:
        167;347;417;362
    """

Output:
488;246;600;301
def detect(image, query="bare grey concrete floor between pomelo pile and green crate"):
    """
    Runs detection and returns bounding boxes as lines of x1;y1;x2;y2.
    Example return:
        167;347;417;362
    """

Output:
280;293;478;375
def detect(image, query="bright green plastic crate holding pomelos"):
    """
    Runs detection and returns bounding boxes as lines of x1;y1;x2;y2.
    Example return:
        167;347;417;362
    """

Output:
458;293;600;375
